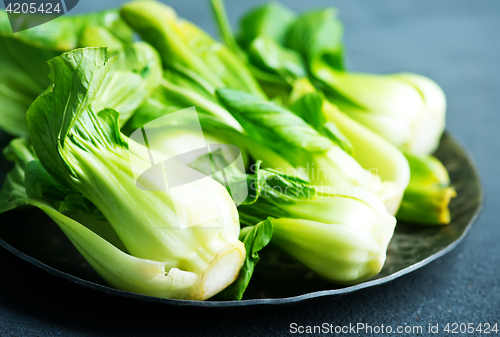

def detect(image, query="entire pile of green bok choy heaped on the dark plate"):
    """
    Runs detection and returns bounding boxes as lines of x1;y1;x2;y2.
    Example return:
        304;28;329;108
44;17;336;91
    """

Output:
0;0;455;300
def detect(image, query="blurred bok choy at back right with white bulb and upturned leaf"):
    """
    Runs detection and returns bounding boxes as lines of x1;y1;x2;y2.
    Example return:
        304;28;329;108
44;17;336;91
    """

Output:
285;10;446;155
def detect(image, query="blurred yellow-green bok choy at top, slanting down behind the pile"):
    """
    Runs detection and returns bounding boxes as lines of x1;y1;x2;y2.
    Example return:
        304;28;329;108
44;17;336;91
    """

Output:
120;1;263;96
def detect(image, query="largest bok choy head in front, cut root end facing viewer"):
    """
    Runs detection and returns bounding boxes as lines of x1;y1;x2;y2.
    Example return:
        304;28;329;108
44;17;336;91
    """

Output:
23;48;244;300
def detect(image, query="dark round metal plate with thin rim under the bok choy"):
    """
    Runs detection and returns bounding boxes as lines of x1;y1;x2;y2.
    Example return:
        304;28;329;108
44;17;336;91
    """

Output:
0;134;483;307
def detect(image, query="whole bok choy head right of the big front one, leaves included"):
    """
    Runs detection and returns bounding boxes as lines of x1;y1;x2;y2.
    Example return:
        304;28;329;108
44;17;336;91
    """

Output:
238;164;396;284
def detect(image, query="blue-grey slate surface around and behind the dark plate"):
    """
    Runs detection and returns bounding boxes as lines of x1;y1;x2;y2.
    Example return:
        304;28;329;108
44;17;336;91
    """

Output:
0;0;500;337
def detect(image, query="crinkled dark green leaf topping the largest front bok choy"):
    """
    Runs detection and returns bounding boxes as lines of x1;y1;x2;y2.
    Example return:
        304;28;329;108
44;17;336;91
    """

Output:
27;48;118;181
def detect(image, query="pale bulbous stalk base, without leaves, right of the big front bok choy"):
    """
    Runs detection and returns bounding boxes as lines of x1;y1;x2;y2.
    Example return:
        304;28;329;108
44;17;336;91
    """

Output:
271;189;396;284
